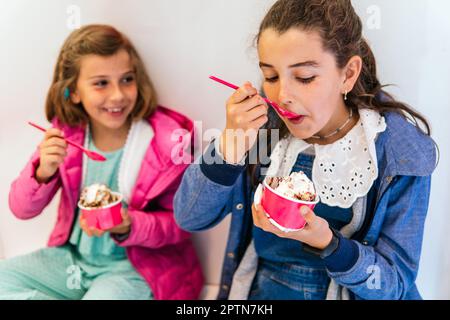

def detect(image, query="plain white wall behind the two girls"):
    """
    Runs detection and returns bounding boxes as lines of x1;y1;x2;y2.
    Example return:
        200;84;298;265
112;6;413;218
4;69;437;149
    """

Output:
0;0;450;299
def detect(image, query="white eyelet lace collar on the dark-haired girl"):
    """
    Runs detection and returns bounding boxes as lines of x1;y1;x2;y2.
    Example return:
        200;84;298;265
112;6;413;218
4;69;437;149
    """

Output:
267;109;386;208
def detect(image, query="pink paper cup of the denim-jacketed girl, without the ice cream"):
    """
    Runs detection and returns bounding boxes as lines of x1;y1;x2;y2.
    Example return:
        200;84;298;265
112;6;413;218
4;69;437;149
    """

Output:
261;179;319;231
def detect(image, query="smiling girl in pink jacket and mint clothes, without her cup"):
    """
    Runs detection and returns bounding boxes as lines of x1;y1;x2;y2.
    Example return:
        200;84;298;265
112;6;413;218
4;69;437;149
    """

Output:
0;25;203;299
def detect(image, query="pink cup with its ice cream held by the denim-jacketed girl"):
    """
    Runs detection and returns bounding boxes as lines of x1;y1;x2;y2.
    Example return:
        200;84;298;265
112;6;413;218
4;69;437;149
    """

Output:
255;172;319;232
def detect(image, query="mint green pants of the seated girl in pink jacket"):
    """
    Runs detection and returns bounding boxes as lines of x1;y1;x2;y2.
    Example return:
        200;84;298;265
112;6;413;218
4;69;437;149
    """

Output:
0;245;152;300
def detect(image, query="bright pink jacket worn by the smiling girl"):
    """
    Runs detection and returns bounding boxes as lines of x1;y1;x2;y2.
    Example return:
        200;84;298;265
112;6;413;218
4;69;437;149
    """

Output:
9;107;203;300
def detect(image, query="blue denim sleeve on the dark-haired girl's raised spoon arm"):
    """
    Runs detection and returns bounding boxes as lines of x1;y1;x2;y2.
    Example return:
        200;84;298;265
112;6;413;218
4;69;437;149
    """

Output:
174;144;245;232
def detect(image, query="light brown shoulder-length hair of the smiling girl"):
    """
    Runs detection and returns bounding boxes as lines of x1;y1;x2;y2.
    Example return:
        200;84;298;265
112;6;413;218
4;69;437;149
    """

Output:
45;25;157;126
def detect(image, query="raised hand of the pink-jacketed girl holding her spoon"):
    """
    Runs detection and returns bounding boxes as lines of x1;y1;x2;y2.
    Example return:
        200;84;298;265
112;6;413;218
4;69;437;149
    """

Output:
36;128;67;183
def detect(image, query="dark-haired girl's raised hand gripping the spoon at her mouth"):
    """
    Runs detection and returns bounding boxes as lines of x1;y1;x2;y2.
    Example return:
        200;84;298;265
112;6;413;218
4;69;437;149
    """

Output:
220;82;269;164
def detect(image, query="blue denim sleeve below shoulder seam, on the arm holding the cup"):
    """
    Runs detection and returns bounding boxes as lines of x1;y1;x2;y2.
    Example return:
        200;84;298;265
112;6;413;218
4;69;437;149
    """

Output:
328;176;431;300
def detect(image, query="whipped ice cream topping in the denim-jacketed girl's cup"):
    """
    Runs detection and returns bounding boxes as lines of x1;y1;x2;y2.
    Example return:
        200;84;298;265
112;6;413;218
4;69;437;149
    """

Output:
267;171;316;202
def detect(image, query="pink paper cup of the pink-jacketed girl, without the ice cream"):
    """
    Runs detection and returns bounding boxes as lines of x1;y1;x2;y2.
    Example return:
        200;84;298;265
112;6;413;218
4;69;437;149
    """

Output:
78;192;123;230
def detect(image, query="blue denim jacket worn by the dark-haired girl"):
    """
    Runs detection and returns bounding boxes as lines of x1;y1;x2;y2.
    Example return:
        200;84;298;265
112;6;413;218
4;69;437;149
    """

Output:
174;112;436;300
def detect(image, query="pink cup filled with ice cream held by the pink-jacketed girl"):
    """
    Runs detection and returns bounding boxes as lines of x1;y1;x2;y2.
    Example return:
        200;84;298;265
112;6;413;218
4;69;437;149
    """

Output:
78;184;123;230
